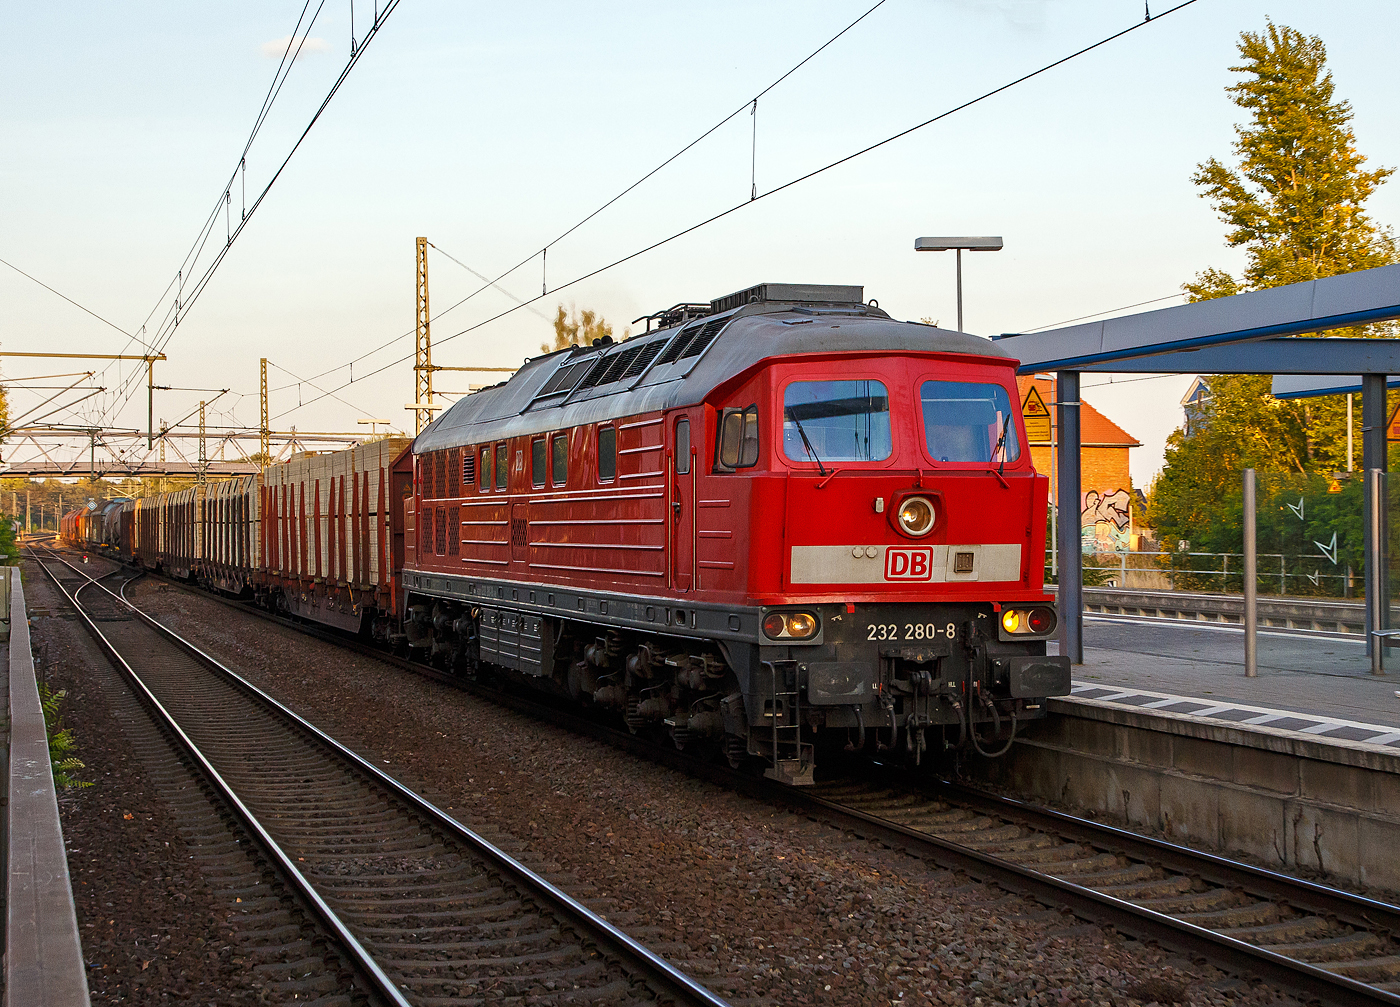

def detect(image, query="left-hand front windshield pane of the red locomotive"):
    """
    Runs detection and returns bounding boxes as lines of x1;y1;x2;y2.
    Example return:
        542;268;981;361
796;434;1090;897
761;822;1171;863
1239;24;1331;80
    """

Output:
783;381;892;464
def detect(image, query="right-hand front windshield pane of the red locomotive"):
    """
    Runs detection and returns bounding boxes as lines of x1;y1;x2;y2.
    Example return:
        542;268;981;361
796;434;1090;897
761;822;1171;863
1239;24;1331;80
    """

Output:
918;381;1021;464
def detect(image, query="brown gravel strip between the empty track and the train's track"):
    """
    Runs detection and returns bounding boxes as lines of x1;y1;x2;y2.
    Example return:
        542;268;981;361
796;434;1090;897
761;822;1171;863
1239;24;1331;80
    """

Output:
109;581;1291;1007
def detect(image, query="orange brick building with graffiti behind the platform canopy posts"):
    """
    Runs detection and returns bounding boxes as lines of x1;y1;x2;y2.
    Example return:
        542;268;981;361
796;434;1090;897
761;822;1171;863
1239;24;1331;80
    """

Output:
1016;374;1140;552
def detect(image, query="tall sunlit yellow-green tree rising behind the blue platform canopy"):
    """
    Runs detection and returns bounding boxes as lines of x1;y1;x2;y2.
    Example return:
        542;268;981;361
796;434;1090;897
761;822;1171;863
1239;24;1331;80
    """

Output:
1149;22;1396;560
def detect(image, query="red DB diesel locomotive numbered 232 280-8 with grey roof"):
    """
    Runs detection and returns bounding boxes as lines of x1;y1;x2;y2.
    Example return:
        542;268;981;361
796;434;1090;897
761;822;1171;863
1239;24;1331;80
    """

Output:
406;284;1070;783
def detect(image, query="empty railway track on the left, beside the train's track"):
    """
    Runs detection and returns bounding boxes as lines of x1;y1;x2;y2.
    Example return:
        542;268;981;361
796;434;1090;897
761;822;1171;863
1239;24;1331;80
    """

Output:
34;550;724;1007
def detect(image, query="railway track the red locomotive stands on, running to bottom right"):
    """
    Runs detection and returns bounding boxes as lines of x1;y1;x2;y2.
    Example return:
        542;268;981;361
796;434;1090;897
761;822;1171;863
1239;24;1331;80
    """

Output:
90;560;1400;1006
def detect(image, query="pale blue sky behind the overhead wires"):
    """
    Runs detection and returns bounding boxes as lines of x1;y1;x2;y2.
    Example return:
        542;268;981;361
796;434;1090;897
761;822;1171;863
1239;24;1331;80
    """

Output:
0;0;1400;487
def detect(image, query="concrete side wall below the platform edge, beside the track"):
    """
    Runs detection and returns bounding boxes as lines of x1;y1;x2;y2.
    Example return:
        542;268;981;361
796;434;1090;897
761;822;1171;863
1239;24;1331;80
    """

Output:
965;699;1400;892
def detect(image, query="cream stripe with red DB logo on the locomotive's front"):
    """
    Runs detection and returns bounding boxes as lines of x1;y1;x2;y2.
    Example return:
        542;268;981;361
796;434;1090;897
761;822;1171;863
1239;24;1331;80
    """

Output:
791;543;1021;584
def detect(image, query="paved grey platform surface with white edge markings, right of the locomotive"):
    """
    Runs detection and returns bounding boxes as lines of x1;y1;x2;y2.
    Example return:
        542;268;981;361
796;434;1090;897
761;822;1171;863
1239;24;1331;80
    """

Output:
1050;616;1400;751
